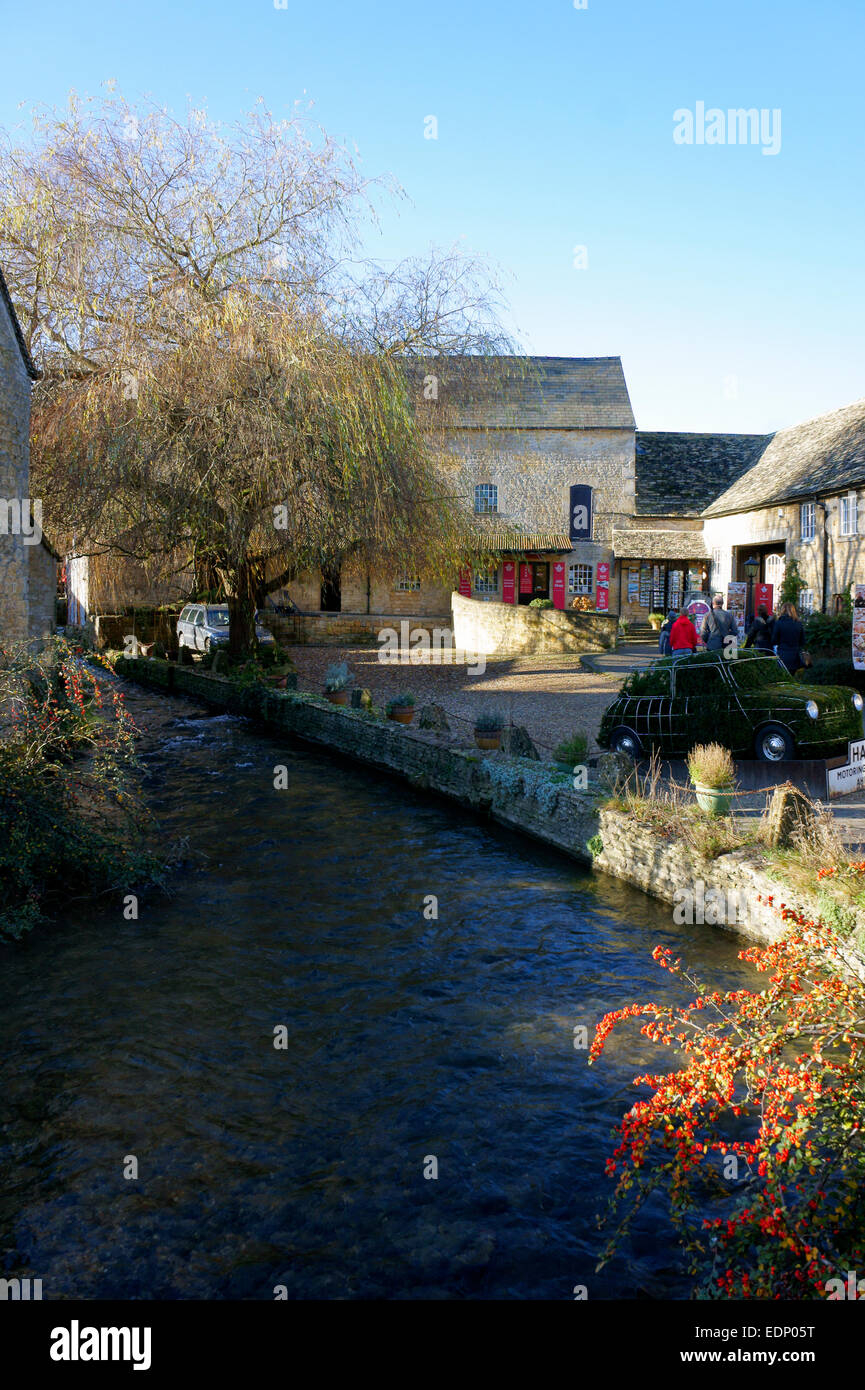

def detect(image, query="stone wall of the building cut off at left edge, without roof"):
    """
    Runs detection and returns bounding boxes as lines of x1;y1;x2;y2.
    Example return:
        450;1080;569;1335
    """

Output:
0;295;33;642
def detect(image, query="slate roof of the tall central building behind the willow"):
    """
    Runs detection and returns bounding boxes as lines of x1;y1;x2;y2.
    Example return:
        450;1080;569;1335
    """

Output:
412;356;634;430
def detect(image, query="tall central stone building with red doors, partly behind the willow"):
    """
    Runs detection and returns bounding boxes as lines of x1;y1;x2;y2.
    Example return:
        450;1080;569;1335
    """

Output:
280;357;634;621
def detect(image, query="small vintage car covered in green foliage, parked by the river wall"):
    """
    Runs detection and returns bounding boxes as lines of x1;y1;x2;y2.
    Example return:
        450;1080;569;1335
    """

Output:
598;651;862;763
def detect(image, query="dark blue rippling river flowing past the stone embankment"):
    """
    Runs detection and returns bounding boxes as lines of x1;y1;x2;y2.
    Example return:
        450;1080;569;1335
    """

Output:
0;678;744;1298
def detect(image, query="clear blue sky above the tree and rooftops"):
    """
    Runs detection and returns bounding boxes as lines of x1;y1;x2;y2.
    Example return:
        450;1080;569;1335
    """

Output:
0;0;865;431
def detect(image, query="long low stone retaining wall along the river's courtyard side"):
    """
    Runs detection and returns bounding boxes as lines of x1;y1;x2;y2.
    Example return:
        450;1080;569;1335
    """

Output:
117;657;865;942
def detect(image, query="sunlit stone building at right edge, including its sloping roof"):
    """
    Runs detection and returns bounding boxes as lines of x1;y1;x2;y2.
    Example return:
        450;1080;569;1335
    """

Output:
702;400;865;612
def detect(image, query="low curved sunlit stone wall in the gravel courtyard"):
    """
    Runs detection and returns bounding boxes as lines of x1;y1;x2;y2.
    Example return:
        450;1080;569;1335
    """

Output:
451;594;616;656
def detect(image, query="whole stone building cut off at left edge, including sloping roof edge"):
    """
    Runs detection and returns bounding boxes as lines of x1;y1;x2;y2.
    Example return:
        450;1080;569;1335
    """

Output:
0;271;57;642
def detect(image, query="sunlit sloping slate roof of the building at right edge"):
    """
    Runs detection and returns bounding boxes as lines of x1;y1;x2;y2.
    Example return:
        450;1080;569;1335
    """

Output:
704;400;865;517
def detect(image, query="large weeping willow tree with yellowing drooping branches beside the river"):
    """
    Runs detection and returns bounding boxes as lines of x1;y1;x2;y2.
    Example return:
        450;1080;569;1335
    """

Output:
0;95;506;652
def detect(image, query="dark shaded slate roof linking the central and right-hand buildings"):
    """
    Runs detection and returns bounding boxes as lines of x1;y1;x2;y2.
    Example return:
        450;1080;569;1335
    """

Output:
636;430;772;517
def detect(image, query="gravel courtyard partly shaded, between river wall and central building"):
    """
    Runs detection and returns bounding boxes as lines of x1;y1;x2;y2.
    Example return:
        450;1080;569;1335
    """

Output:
289;646;622;758
